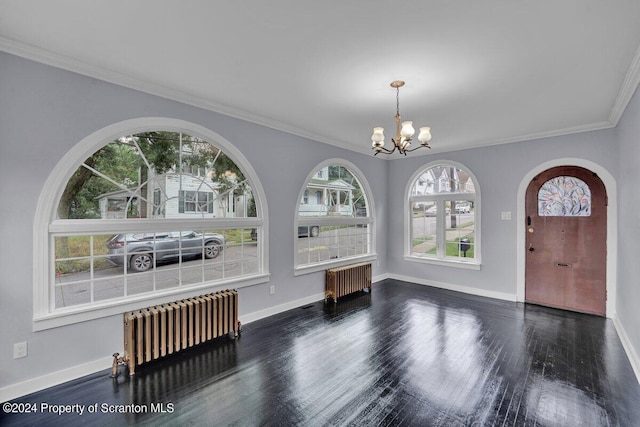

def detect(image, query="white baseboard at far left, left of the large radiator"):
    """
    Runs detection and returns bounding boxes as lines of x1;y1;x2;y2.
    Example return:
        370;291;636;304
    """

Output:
0;357;113;402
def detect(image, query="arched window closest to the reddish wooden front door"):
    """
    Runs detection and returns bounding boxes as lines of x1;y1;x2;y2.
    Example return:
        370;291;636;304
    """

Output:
405;162;480;268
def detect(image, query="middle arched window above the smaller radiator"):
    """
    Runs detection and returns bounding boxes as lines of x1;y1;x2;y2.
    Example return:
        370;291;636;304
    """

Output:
294;159;375;273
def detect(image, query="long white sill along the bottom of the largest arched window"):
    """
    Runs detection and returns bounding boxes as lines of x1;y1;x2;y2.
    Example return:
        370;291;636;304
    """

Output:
33;273;270;331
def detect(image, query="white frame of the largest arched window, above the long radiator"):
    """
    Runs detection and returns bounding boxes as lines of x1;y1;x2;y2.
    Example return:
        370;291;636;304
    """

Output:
33;117;270;331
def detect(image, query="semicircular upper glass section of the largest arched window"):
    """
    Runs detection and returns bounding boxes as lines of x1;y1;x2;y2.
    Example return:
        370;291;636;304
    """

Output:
57;131;256;219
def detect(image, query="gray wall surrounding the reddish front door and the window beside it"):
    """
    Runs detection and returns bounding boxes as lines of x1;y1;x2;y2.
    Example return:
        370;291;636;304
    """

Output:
387;129;618;296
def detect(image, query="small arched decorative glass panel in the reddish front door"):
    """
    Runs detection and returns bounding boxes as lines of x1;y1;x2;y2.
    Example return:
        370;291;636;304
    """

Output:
538;176;591;216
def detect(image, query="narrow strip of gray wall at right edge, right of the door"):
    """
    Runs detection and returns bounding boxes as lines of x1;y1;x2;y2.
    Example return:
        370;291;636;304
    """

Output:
616;83;640;357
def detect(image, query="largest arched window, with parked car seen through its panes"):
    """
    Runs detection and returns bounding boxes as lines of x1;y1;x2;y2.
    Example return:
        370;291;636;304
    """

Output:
35;119;266;327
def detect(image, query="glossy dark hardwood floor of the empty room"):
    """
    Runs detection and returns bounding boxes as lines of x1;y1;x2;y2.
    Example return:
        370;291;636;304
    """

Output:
0;280;640;426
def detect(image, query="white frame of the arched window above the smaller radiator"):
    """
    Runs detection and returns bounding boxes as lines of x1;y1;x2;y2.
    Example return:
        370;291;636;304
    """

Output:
293;158;377;276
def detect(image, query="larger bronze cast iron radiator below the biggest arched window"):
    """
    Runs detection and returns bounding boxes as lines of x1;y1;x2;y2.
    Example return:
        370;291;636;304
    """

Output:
112;290;240;377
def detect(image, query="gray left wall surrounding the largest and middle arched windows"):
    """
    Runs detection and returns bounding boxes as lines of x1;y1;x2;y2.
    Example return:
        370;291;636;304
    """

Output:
0;52;387;388
